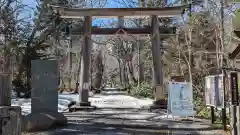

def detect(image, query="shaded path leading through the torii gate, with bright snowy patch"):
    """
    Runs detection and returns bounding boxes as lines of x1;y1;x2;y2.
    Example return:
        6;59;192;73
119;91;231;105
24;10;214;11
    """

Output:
23;89;226;135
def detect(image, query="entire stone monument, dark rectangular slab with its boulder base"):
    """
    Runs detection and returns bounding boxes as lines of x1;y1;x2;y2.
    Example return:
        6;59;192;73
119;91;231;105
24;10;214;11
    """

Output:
23;60;67;132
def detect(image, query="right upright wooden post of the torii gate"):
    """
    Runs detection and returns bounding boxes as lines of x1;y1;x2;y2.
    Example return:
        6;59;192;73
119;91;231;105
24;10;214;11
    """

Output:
152;15;165;105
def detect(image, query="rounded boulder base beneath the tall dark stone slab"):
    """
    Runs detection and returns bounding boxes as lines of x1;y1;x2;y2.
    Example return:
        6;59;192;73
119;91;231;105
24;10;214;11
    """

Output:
23;112;67;132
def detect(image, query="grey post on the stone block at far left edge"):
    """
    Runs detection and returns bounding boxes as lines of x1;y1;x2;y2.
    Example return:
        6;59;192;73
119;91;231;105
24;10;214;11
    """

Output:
0;73;12;106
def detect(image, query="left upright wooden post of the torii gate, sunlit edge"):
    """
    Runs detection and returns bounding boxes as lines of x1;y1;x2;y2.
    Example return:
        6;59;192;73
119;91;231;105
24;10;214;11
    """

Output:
79;16;92;106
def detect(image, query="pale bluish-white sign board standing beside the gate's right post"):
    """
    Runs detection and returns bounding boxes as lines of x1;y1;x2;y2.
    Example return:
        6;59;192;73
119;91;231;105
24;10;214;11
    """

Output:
168;82;195;116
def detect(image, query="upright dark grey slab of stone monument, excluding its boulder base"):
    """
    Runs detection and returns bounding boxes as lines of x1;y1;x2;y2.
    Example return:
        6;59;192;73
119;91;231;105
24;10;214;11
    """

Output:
31;60;59;113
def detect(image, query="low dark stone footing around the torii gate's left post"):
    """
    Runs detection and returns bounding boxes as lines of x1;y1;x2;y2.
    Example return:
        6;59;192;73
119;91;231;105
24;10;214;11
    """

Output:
69;102;97;112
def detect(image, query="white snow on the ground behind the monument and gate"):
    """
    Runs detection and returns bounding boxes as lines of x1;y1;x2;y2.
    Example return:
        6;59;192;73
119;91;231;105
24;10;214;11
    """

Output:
12;92;153;115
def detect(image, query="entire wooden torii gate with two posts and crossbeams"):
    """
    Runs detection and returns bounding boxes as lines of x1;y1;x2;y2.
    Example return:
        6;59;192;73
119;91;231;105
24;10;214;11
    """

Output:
52;6;184;106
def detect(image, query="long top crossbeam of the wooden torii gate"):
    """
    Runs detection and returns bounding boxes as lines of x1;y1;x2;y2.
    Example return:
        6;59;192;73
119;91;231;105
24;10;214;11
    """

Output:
51;6;184;19
